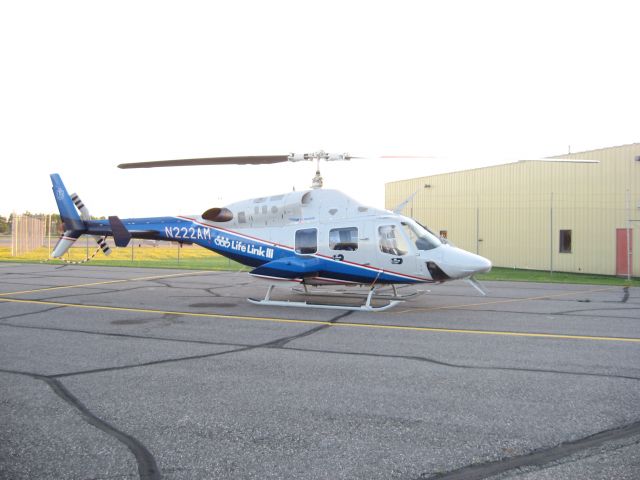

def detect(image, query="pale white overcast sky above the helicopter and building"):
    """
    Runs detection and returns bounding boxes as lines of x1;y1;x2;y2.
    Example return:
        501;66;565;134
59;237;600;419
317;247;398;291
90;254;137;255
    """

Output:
0;0;640;217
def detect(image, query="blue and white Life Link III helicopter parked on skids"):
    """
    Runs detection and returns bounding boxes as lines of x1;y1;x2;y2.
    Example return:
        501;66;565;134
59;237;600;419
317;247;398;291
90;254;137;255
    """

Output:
51;151;491;311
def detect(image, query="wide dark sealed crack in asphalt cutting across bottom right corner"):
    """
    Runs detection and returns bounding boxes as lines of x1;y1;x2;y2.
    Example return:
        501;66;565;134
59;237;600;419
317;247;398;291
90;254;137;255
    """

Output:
416;421;640;480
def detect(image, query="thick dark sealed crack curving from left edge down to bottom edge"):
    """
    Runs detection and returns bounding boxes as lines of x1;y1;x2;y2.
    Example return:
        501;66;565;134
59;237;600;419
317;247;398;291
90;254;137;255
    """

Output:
0;368;161;480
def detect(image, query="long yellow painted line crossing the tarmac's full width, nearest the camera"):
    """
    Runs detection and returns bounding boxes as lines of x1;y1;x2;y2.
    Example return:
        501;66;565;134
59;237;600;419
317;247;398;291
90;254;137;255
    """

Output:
0;298;640;343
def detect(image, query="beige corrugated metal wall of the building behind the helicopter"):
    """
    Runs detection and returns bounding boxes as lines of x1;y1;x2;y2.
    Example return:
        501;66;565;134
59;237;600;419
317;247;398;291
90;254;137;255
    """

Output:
385;143;640;276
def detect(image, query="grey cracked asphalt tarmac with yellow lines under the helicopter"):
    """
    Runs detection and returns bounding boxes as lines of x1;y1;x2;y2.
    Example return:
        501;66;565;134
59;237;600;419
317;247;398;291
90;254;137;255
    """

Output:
0;263;640;480
